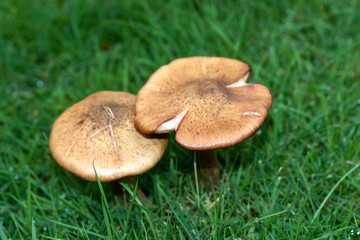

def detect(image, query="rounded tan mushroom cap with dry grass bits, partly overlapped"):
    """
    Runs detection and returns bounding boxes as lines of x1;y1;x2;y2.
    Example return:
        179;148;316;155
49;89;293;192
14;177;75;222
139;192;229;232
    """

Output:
49;91;169;182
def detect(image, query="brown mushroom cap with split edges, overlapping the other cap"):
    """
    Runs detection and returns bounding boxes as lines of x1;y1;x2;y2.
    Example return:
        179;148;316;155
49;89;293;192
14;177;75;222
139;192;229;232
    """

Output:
135;57;272;150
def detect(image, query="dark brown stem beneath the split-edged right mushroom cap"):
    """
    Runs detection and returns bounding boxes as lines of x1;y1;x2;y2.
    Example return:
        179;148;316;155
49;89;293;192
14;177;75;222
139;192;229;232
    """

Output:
198;150;220;186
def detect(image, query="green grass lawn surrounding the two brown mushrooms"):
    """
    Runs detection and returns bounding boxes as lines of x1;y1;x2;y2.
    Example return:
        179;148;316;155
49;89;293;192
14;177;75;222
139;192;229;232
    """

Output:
0;0;360;239
